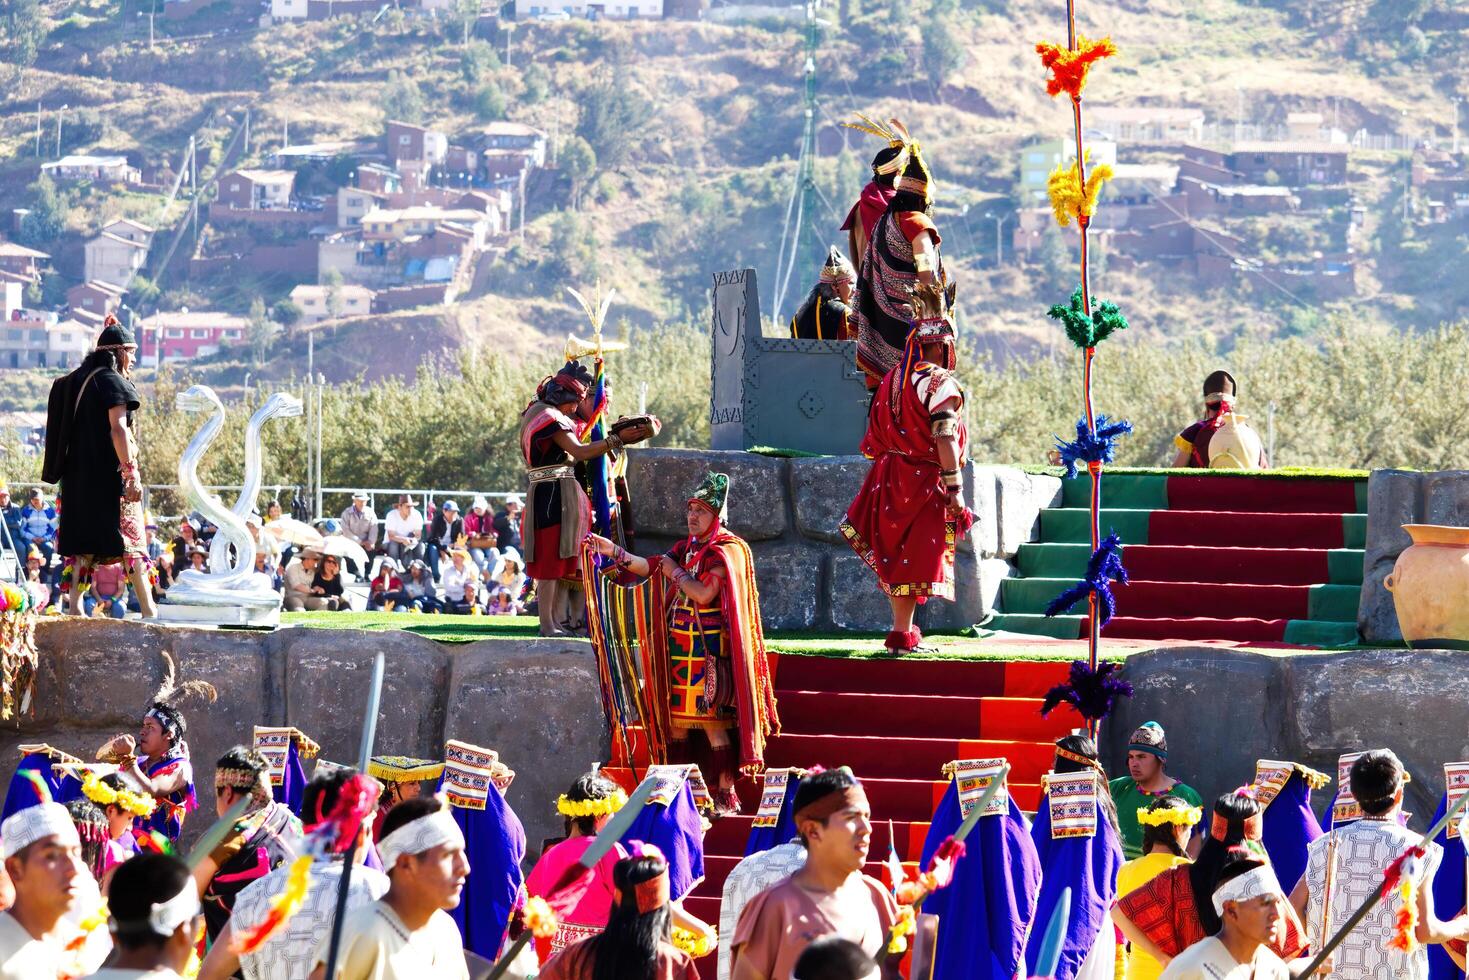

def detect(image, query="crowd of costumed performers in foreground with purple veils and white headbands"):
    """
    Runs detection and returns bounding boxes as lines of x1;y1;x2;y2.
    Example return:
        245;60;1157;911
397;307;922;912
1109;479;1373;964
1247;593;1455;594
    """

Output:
0;675;1469;980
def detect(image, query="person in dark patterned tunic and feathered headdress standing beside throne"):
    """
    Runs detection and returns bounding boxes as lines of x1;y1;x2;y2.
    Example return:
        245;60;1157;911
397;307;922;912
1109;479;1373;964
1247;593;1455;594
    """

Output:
852;143;953;389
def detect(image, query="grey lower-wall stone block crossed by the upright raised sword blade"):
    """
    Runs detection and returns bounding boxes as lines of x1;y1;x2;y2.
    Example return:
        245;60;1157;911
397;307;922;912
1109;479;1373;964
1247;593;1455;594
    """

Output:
276;629;449;764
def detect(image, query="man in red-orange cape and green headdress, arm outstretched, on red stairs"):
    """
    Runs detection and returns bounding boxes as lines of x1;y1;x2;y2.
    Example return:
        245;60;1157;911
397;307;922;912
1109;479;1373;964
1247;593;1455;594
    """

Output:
589;473;780;815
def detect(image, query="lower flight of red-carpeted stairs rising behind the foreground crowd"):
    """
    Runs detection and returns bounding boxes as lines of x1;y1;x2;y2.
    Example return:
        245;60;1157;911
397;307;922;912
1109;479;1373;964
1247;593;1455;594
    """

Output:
607;654;1081;946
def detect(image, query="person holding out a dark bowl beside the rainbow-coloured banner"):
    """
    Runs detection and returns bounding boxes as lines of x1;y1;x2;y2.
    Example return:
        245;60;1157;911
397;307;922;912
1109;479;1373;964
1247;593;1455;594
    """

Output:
517;361;658;636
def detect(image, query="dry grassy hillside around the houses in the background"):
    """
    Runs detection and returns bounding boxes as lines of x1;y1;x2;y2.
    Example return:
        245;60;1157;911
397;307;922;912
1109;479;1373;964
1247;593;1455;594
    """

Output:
0;0;1469;390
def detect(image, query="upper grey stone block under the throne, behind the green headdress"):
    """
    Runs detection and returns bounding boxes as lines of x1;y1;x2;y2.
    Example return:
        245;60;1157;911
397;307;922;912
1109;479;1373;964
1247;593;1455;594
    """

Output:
627;448;789;541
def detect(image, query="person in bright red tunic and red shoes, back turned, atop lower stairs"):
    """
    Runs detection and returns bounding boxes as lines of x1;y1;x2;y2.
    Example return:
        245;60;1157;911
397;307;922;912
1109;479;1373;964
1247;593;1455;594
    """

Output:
842;284;974;654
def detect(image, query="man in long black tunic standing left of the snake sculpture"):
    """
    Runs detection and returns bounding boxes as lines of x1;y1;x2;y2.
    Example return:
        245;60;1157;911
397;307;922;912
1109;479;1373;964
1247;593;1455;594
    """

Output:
47;316;157;619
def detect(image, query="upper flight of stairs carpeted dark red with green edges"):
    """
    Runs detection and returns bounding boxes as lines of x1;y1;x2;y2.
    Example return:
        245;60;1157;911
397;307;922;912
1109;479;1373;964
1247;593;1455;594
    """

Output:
987;472;1366;646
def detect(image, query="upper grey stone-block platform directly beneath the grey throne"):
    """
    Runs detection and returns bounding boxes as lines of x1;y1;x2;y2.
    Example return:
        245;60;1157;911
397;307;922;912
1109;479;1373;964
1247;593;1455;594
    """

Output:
629;450;1061;630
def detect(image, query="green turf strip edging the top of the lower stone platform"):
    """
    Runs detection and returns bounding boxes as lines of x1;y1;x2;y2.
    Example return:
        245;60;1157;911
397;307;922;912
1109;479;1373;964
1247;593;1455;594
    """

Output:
281;611;1127;661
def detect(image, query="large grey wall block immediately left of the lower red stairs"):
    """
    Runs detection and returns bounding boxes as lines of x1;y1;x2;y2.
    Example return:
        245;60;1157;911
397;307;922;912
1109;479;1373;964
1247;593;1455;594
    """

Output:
441;639;610;854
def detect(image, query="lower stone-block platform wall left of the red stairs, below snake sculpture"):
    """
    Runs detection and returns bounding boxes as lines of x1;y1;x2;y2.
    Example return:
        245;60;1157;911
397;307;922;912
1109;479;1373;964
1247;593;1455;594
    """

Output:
18;619;608;843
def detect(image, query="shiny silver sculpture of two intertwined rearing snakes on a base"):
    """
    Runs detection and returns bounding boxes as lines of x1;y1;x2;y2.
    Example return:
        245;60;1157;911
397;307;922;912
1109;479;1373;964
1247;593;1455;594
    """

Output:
165;385;303;610
